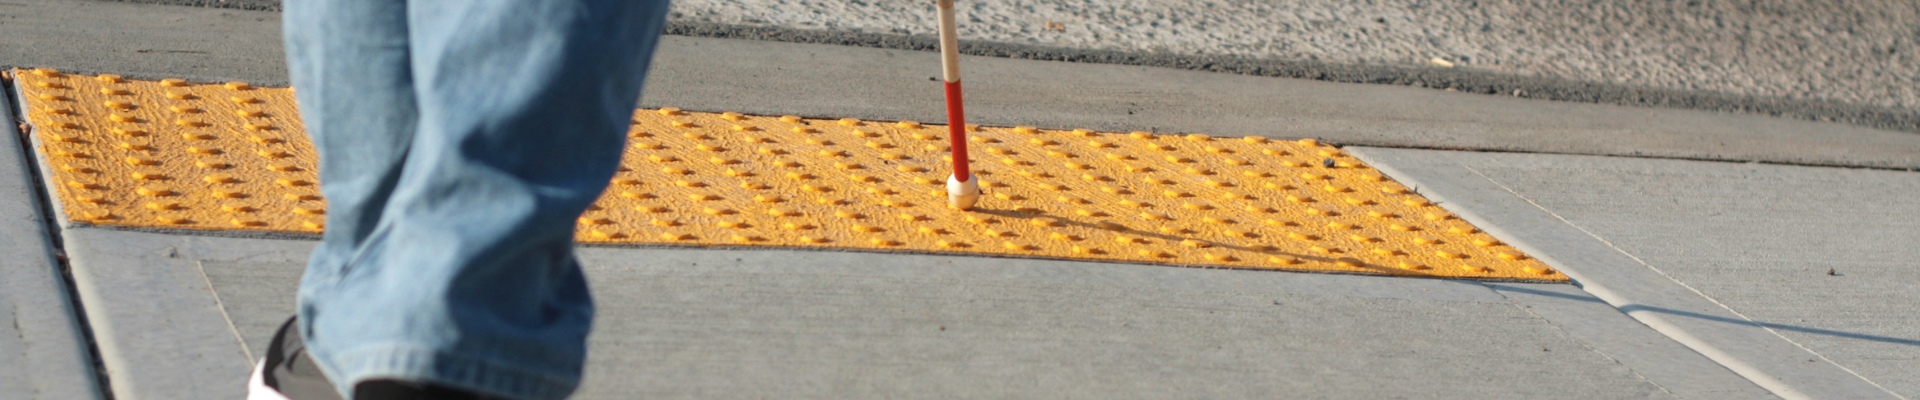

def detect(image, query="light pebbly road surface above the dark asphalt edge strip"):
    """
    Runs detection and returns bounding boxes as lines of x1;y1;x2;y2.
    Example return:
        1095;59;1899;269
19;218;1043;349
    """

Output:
674;0;1920;110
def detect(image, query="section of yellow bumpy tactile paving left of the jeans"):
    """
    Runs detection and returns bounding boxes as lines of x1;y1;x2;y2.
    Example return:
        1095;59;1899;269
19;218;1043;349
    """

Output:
13;69;326;233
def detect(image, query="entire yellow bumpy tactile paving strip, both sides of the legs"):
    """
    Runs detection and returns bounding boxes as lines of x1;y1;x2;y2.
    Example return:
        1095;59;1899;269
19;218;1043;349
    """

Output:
15;69;1565;281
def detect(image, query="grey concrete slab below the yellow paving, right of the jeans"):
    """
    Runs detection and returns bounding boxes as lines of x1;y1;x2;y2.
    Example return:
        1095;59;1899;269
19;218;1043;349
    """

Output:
560;248;1764;398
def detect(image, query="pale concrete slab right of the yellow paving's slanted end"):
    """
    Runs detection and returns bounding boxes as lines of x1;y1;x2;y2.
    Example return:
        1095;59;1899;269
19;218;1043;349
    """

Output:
1350;148;1920;398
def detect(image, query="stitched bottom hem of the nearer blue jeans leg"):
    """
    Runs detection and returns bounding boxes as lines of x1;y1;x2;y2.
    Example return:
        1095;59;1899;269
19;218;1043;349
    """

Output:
330;346;580;400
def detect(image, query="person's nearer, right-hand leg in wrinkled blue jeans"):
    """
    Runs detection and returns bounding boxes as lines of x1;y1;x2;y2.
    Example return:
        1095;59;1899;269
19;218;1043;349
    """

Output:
301;0;666;398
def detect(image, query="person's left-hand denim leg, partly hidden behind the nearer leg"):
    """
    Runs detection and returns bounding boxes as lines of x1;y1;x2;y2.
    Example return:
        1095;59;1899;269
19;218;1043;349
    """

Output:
280;0;419;390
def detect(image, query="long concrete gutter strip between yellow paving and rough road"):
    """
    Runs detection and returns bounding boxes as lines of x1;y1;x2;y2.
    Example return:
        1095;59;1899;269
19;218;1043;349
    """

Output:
0;0;1920;169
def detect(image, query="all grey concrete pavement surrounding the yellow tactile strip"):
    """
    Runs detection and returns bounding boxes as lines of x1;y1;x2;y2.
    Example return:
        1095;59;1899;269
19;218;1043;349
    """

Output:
0;0;1920;400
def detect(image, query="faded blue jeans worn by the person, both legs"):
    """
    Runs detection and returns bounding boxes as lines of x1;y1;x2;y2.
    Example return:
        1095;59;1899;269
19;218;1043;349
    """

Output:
284;0;666;398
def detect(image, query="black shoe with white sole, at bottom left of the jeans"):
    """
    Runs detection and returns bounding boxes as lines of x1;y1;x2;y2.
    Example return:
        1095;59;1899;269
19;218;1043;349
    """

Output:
246;317;342;400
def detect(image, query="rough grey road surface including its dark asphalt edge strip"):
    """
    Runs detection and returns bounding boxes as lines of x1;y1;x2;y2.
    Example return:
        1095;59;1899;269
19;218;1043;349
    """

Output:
101;0;1920;133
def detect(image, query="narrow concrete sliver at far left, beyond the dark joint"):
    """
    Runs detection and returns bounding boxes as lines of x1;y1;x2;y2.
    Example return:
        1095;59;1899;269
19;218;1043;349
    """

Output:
0;76;100;398
